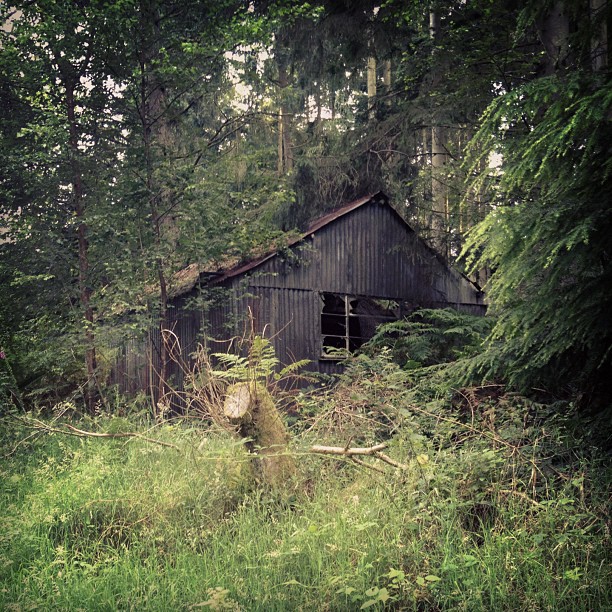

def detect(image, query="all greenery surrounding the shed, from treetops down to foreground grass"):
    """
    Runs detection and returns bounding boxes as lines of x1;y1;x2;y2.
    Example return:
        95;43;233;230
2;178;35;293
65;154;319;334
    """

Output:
0;0;612;612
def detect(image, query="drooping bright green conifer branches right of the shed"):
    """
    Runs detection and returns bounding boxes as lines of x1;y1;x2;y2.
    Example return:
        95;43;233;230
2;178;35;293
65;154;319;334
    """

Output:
467;73;612;388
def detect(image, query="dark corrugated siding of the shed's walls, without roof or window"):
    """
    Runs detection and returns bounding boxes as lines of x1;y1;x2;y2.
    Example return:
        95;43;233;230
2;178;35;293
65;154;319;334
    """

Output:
109;196;484;390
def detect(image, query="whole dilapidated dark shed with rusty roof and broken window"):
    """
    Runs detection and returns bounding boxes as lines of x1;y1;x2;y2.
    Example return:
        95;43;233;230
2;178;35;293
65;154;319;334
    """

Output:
114;192;486;393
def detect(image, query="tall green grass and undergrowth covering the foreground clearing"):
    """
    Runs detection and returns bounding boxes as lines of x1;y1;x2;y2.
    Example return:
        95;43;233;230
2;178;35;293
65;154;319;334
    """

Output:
0;380;612;612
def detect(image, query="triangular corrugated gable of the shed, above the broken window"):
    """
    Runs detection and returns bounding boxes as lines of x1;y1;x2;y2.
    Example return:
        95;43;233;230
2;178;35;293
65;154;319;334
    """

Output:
237;203;478;304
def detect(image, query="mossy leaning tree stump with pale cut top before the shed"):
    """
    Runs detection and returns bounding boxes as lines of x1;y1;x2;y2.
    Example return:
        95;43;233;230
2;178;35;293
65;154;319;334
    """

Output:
223;382;295;488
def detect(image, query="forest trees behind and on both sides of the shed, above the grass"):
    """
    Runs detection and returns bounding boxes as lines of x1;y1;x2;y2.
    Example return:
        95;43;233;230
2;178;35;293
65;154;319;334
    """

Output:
0;0;612;412
